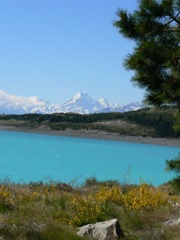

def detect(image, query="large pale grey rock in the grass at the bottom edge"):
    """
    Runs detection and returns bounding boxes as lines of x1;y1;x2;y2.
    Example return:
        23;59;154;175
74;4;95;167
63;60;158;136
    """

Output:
77;219;124;240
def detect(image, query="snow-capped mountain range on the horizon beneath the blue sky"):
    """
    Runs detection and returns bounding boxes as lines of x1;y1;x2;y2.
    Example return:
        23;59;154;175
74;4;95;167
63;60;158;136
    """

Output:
0;90;143;114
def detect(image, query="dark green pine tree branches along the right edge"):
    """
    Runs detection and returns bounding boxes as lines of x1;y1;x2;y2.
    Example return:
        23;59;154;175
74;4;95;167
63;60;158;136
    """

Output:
114;0;180;191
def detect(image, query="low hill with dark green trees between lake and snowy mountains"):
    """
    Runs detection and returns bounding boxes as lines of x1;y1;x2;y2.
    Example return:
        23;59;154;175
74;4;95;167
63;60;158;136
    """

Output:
0;107;180;138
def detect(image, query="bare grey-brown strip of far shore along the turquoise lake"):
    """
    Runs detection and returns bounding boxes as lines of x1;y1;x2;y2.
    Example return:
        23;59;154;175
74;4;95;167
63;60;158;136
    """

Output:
0;125;180;147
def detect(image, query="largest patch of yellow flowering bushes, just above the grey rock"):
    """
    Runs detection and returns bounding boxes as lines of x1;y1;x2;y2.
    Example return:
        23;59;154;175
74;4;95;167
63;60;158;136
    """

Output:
58;183;172;226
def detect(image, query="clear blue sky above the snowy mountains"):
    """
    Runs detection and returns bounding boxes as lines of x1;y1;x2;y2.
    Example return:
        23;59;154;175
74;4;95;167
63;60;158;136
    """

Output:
0;0;144;104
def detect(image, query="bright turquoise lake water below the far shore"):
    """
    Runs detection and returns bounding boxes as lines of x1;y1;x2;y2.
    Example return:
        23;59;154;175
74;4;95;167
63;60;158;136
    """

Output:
0;131;180;186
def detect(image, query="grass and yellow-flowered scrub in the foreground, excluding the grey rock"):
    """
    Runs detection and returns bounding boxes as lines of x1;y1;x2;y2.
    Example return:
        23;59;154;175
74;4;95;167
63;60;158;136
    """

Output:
0;178;180;240
